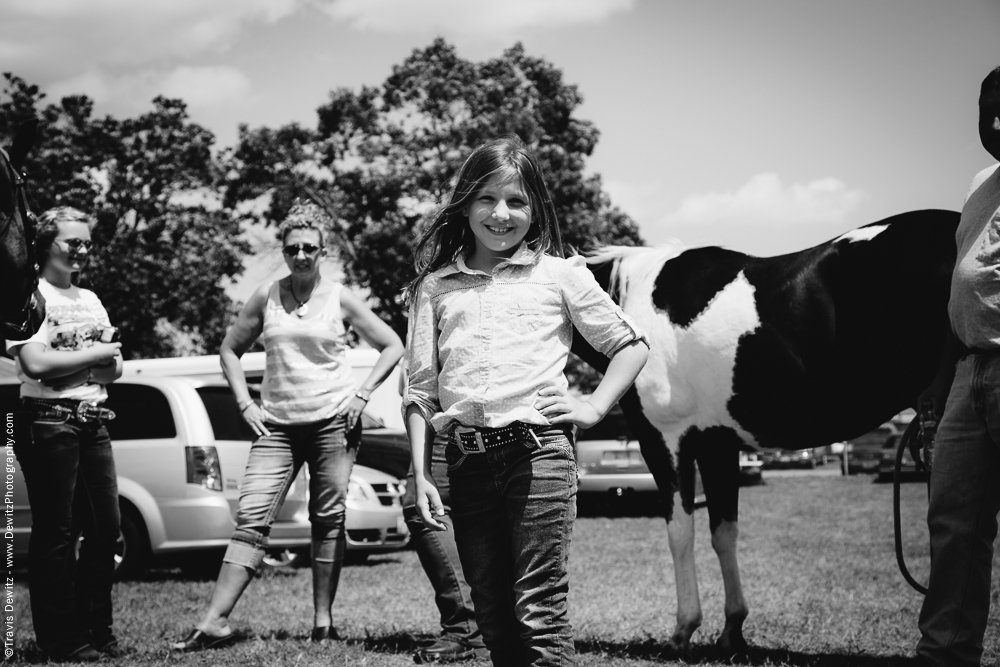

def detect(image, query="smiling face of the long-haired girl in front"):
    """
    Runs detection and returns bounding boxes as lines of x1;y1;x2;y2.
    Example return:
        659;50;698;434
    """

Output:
465;173;531;266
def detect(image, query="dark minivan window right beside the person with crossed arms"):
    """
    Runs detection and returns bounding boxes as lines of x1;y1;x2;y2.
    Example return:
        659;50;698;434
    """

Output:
104;382;177;442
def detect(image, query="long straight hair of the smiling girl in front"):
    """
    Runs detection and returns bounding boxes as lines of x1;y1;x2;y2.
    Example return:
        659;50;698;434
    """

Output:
404;134;563;300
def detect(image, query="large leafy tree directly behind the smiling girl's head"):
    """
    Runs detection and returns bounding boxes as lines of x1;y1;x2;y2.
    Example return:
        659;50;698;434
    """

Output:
225;39;641;340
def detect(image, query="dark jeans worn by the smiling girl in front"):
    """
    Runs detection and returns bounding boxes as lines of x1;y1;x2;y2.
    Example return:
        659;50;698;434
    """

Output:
445;427;576;667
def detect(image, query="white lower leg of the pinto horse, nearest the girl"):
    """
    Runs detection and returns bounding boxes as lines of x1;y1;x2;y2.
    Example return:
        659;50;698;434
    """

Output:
667;500;701;653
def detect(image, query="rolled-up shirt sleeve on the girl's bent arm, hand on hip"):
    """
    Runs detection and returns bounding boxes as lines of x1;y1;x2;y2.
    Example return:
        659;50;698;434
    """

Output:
560;257;649;358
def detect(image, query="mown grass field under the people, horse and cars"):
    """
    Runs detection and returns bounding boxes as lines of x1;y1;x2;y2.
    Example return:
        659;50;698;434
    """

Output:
12;477;1000;667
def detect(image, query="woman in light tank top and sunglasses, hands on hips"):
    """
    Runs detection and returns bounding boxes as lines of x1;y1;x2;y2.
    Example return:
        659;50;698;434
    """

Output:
173;201;403;651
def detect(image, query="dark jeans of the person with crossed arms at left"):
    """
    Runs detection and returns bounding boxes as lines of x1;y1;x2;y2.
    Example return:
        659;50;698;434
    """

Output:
15;407;120;656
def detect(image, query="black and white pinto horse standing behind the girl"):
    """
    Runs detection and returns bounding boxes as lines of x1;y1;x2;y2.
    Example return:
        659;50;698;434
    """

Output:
574;210;959;653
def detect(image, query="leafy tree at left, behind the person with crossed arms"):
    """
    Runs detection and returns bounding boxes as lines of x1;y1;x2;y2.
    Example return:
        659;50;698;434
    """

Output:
0;73;249;358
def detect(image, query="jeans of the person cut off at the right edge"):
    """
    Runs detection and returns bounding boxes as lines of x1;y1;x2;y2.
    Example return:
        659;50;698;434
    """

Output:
917;353;1000;667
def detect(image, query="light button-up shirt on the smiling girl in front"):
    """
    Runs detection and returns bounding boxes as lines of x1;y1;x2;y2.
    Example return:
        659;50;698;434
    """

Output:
403;245;646;433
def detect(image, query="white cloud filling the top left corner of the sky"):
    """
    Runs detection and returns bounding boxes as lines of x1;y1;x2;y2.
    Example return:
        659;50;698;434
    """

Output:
0;0;306;73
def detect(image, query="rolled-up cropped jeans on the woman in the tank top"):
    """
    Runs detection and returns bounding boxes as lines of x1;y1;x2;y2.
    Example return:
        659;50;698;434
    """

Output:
223;416;361;570
